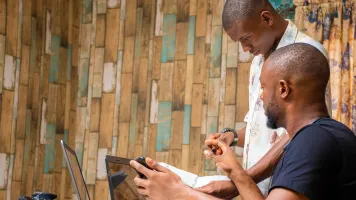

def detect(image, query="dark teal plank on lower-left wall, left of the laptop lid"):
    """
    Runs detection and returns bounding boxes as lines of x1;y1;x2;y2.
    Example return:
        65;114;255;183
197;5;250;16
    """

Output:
43;124;56;173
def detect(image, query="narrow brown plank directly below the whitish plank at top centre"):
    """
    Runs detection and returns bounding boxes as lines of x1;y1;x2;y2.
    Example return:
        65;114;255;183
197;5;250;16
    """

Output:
152;37;162;80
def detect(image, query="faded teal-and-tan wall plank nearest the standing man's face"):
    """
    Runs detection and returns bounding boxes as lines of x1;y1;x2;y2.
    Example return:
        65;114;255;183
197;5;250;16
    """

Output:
210;26;222;78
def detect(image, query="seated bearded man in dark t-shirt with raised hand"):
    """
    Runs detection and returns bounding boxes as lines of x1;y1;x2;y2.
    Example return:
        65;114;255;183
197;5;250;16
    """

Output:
205;43;356;200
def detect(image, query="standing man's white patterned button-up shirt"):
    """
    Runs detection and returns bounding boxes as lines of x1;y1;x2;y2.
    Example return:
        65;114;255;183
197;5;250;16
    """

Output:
243;20;328;196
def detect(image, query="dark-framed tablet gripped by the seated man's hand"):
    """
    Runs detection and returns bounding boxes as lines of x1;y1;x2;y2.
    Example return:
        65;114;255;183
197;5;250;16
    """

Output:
105;155;145;200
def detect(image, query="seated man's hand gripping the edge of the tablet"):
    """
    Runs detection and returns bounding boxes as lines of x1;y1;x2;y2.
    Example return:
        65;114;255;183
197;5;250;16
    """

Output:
130;158;187;200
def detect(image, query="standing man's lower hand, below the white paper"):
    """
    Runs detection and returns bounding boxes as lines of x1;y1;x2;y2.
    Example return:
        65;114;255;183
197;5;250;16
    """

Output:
196;181;239;199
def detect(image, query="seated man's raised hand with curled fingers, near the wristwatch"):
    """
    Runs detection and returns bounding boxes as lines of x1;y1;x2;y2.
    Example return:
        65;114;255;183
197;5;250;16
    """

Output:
204;140;241;179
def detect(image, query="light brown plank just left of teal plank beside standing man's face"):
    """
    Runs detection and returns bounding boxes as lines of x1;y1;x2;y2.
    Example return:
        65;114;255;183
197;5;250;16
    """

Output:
193;37;206;83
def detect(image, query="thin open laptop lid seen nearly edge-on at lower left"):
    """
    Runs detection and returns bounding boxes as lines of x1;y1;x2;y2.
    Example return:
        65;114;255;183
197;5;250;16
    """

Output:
61;140;90;200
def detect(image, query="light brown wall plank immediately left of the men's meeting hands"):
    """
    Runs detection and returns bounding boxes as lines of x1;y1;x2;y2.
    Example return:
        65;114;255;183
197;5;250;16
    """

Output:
188;128;202;174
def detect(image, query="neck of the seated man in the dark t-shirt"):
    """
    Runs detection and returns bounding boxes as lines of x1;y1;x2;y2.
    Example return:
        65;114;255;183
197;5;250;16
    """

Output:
283;103;329;138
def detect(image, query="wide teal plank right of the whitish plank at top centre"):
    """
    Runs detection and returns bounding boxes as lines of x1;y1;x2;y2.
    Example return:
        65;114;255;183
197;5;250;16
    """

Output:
161;14;176;63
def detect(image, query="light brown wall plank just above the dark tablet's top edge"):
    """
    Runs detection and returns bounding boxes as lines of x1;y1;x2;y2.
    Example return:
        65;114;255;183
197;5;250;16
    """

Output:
116;122;130;158
